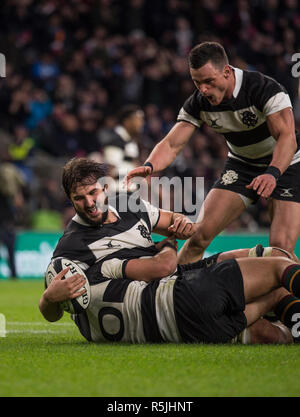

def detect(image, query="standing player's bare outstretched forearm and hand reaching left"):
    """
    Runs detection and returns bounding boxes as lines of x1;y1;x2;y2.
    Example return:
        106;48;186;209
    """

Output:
124;122;195;188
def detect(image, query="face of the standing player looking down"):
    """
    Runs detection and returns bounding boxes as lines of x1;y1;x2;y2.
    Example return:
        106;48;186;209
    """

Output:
190;62;233;106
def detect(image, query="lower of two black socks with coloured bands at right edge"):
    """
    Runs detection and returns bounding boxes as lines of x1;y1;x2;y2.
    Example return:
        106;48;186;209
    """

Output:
274;294;300;343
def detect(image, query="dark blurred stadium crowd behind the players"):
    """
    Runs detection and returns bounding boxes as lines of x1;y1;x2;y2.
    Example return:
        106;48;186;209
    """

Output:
0;0;300;232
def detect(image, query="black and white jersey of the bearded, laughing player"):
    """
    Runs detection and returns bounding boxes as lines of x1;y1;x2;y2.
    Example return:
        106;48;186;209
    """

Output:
53;193;160;277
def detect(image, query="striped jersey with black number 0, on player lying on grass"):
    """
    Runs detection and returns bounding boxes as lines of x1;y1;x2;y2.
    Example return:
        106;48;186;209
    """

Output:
72;272;182;343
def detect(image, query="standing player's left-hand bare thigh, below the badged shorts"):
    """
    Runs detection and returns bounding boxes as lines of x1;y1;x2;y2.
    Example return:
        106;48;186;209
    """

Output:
196;188;245;238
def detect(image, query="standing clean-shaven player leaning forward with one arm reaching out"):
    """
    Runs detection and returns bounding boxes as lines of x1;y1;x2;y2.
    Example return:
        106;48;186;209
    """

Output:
125;42;300;263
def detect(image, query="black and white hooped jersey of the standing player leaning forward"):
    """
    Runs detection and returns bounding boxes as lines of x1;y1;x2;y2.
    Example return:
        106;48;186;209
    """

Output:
177;68;300;166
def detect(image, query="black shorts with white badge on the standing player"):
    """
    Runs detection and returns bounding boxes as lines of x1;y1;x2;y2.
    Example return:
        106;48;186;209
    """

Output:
212;158;300;203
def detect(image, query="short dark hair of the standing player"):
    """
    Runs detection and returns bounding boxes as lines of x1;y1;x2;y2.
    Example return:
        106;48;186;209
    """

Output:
188;42;228;69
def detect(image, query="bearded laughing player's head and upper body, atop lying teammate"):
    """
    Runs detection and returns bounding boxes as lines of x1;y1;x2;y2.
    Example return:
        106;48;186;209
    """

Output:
49;158;195;278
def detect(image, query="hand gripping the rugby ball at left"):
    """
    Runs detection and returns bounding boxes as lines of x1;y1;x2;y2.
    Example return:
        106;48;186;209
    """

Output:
44;268;86;303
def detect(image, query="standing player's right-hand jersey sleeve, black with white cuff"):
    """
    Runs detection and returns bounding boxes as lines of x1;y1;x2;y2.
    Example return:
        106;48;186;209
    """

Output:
257;77;292;116
